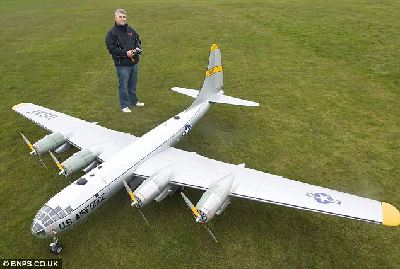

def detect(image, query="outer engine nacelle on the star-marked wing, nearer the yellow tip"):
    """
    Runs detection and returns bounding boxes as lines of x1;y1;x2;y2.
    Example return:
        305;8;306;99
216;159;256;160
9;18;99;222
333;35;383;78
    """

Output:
196;175;234;222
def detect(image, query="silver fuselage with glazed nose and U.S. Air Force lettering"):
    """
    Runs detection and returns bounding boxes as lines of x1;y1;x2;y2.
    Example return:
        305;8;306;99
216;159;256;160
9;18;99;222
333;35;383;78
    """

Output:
32;101;211;238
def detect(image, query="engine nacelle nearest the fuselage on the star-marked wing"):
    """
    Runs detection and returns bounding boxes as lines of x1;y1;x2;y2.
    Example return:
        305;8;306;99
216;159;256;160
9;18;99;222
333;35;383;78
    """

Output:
133;174;170;207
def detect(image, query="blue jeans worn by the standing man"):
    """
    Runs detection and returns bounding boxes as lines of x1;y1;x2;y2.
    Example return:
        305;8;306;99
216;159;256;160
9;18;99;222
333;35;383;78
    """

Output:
115;64;138;109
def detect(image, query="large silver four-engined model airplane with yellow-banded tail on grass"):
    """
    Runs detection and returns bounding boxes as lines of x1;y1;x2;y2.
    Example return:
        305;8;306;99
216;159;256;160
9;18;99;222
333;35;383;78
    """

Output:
13;44;400;254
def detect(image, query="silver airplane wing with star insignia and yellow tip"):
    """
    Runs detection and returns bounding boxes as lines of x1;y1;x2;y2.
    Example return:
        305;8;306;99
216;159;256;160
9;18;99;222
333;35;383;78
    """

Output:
135;148;400;226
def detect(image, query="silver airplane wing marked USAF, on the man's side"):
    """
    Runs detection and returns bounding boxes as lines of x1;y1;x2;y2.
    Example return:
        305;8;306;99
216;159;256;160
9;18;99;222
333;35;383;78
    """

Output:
12;103;137;162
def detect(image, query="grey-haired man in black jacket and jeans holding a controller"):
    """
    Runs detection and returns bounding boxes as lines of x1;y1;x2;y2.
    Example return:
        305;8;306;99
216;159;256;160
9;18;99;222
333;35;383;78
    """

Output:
105;8;144;112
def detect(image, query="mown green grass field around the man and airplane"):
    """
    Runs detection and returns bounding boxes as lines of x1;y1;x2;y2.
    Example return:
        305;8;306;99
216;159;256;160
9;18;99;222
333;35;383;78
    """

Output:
0;0;400;268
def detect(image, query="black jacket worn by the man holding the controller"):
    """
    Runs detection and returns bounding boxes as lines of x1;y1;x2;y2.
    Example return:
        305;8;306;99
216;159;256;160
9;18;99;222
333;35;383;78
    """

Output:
105;24;142;66
